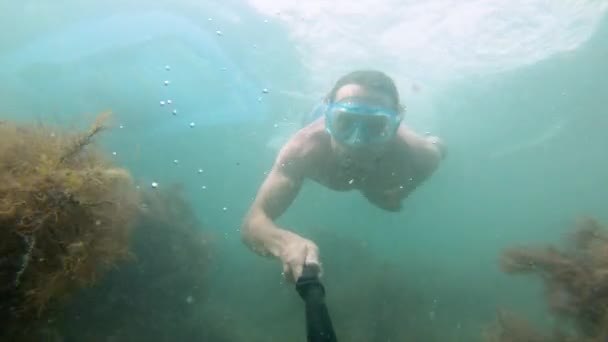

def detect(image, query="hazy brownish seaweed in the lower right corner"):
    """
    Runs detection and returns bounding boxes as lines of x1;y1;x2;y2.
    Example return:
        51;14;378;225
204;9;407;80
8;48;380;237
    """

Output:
488;218;608;342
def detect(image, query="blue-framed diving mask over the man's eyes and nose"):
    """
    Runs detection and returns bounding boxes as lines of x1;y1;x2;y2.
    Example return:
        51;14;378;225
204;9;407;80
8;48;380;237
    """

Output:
325;101;401;145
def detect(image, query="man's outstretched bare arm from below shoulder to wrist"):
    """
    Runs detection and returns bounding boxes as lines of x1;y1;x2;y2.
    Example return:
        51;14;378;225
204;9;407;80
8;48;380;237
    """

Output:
241;143;304;257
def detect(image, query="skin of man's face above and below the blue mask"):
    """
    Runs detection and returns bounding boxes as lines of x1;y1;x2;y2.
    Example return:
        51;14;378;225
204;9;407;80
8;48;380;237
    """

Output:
332;84;400;161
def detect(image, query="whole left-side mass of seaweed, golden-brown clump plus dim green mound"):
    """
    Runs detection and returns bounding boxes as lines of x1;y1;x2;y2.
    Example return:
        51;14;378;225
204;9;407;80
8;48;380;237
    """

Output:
0;114;221;341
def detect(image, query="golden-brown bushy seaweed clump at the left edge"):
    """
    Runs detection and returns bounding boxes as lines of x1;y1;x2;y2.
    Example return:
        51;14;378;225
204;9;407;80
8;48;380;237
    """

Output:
0;113;138;338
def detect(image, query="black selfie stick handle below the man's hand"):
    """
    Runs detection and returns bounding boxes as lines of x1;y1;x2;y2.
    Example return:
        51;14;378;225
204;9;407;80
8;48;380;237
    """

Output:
296;266;337;342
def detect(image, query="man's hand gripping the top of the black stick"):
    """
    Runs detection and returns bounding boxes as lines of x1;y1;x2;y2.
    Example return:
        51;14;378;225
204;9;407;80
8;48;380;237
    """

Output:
280;235;322;283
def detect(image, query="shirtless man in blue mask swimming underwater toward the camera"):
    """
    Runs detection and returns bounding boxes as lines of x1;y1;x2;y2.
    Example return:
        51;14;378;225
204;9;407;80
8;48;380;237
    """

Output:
241;70;446;282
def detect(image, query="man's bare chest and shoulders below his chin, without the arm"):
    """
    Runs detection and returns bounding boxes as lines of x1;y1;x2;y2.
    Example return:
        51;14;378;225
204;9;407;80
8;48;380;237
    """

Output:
292;120;440;211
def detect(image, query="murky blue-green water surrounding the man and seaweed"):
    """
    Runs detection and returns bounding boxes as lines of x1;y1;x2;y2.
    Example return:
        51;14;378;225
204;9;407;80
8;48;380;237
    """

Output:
0;0;608;341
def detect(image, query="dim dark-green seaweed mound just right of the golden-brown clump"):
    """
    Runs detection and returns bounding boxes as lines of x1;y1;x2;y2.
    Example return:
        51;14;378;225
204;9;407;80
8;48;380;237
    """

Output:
54;186;222;341
